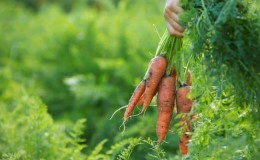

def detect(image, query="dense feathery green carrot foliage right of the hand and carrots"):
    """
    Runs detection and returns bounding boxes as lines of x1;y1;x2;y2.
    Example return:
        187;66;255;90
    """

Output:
176;0;260;159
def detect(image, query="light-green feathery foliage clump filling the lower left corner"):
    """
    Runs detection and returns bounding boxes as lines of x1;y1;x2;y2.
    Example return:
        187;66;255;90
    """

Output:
0;69;85;160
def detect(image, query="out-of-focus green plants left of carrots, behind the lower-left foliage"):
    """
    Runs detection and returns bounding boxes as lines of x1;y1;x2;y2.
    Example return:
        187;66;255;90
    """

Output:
0;1;163;147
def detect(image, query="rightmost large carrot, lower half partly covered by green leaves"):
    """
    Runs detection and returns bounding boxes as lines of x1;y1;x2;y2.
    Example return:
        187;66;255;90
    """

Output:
176;86;192;155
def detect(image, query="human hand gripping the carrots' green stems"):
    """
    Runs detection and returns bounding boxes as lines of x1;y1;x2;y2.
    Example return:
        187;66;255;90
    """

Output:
164;0;184;37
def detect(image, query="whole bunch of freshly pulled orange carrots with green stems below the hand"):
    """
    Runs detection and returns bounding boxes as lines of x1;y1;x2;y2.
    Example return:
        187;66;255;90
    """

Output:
123;33;193;155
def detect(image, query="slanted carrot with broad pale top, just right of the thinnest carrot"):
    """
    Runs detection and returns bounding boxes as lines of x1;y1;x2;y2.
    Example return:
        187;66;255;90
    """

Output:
142;56;167;112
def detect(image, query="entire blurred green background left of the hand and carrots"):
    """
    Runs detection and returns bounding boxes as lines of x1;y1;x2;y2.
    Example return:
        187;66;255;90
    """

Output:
0;0;182;160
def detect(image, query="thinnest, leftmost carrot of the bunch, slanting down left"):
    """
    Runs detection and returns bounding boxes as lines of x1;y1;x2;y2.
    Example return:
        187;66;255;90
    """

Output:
124;80;145;122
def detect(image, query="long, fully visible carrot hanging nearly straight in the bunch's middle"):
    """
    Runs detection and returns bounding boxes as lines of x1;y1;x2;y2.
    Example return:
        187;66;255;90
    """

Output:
156;76;175;144
